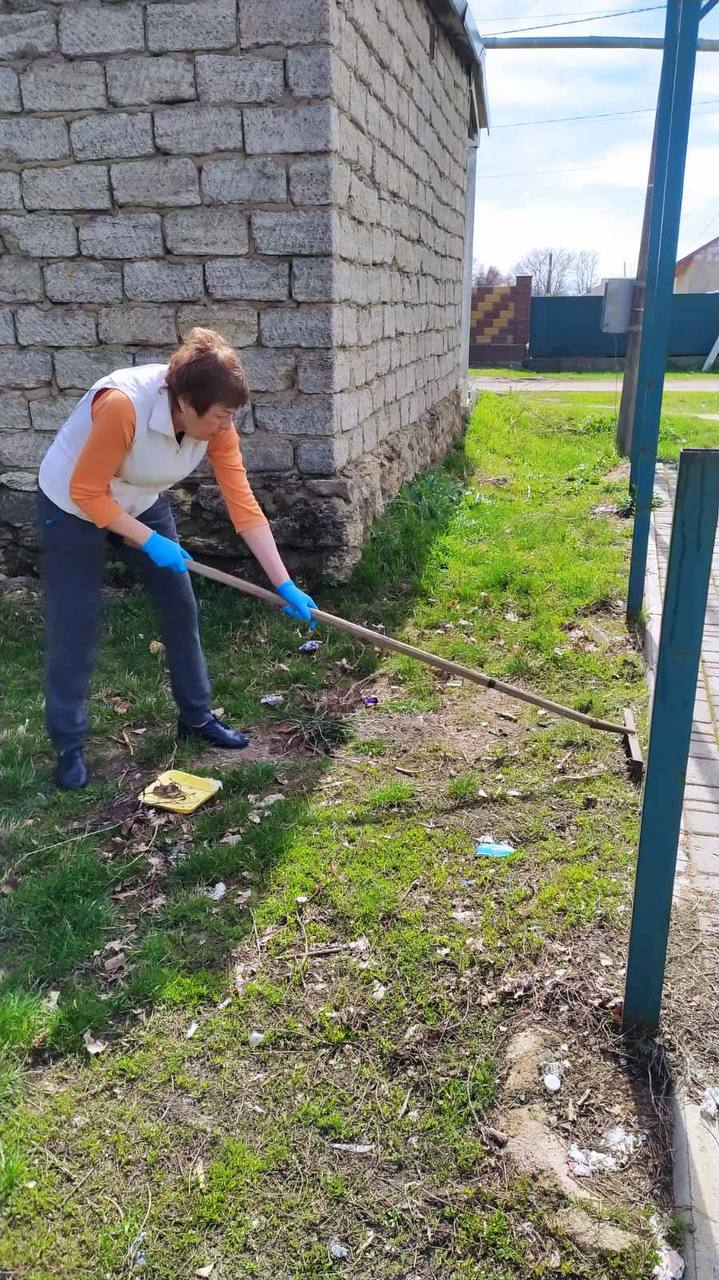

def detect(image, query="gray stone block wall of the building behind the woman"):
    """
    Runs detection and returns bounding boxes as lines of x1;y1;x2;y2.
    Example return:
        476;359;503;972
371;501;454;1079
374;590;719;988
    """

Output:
0;0;470;577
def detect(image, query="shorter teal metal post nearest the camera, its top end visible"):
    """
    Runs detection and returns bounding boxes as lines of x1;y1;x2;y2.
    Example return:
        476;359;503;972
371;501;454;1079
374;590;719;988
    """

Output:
623;449;719;1032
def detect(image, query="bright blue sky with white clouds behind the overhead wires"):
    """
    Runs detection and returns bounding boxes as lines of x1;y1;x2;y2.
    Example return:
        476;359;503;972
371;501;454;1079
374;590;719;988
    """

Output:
472;0;719;276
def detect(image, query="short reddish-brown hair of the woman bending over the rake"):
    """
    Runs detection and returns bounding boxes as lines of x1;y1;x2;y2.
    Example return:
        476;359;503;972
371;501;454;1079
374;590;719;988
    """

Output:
166;329;249;416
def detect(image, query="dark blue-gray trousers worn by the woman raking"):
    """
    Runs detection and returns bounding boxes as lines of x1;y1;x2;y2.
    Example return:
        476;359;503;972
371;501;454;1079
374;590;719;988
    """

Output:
38;492;211;751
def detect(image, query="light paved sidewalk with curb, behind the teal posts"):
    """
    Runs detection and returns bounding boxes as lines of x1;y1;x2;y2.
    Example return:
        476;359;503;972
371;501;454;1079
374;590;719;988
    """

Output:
646;466;719;1280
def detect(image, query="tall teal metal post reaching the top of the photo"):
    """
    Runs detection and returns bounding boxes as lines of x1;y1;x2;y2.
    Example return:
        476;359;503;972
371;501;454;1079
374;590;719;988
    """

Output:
627;0;700;621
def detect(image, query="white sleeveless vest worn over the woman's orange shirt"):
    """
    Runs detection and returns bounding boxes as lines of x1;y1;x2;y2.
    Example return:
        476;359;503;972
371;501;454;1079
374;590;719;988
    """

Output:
38;365;207;520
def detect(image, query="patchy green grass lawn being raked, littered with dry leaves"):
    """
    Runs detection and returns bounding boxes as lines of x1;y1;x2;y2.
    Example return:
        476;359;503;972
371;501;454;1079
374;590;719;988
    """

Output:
0;396;685;1280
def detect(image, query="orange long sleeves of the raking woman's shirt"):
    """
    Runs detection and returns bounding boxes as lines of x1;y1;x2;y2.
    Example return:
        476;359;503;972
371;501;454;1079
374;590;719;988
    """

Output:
70;389;267;534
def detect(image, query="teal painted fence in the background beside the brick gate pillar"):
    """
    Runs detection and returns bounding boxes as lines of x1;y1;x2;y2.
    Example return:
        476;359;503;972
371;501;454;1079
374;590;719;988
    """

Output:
530;293;719;360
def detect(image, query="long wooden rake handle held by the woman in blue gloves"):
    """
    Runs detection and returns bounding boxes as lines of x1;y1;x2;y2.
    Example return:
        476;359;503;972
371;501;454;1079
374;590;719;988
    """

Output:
187;561;628;737
